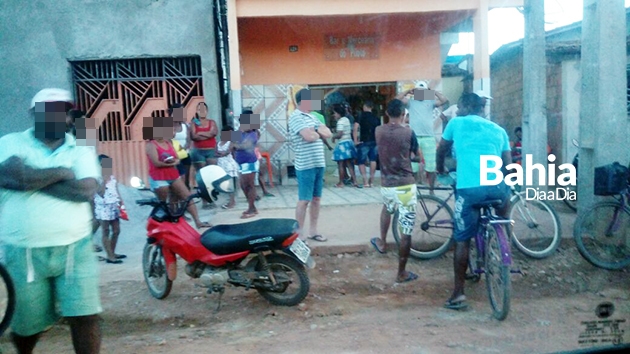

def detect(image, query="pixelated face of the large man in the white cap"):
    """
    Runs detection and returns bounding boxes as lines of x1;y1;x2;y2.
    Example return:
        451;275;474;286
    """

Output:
33;102;71;140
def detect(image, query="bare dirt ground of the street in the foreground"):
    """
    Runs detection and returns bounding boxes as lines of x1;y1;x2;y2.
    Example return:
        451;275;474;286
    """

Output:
0;240;630;354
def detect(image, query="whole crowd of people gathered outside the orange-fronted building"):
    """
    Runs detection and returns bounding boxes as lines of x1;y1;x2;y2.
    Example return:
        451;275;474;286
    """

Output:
0;83;512;353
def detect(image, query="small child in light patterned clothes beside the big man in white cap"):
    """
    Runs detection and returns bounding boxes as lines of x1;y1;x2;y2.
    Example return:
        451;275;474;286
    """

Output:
94;155;127;264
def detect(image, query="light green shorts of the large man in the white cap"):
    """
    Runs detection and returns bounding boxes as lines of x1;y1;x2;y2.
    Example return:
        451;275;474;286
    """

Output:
3;237;102;337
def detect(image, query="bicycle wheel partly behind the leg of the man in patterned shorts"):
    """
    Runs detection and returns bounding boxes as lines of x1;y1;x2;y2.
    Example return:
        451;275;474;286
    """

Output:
392;193;453;259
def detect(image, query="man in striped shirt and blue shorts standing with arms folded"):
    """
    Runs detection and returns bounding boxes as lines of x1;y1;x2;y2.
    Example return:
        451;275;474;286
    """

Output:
289;89;332;242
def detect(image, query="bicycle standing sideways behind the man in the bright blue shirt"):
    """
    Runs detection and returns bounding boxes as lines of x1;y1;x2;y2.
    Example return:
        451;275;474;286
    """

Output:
392;184;562;260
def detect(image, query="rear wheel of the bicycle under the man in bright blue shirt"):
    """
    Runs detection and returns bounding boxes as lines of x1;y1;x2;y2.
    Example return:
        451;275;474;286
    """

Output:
485;224;512;321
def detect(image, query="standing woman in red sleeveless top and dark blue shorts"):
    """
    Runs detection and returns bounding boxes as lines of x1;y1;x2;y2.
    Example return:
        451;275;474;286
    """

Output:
190;102;219;209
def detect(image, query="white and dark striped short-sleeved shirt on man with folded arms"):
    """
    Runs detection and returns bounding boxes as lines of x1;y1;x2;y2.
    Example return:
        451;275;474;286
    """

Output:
289;109;326;171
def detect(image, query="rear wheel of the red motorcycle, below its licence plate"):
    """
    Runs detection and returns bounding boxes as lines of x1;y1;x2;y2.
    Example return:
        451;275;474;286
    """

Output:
256;254;311;306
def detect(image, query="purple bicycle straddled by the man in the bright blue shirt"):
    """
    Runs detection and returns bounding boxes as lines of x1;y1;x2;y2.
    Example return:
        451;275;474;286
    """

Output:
466;200;520;321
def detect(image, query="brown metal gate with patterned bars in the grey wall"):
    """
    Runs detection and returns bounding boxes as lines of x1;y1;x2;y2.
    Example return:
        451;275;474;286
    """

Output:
70;56;204;184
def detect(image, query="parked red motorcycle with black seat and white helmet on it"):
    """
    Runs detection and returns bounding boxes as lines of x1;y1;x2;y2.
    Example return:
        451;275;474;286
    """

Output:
132;165;315;306
